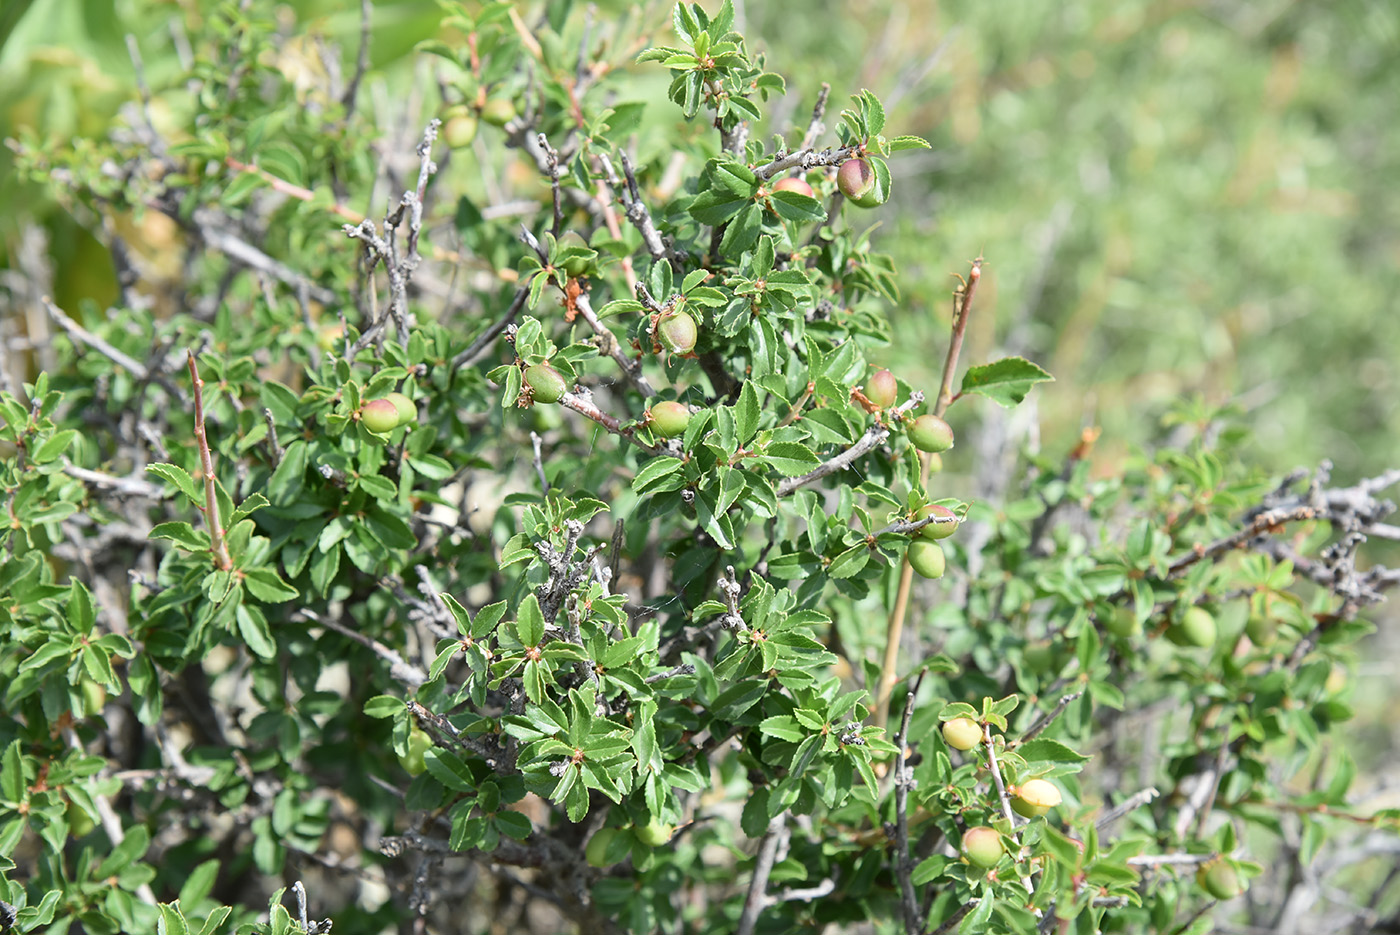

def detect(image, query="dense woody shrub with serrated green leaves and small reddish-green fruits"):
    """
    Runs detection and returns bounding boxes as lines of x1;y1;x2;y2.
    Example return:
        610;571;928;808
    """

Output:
0;3;1397;934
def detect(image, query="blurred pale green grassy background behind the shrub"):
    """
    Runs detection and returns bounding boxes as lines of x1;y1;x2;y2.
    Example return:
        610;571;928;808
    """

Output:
0;0;1400;479
